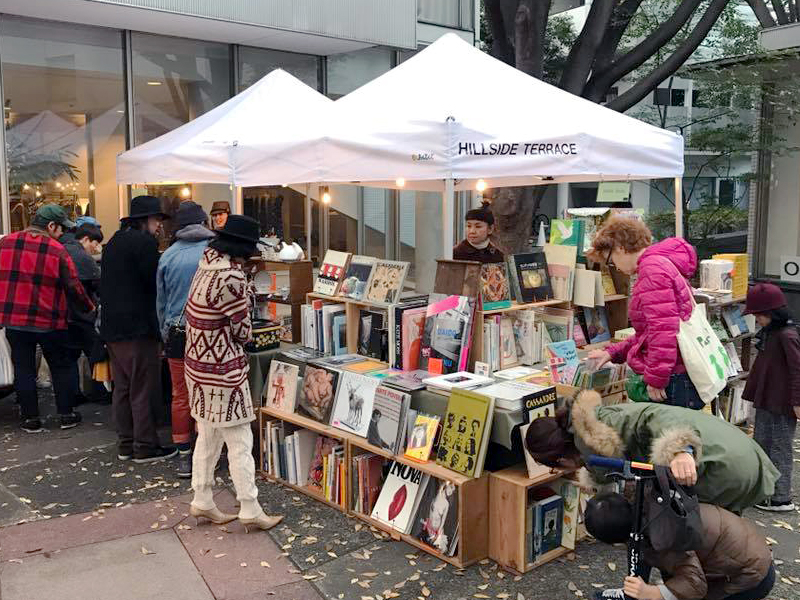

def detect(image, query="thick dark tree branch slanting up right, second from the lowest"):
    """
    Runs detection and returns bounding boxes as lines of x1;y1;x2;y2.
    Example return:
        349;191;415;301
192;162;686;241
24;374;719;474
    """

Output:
587;0;702;102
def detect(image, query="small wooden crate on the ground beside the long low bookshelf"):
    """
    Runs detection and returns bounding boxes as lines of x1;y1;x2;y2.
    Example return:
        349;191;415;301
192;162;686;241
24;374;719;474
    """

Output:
489;465;577;575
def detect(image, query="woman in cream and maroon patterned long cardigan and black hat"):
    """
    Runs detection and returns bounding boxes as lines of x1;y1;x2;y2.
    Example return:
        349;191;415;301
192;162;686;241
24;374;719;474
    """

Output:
184;215;283;529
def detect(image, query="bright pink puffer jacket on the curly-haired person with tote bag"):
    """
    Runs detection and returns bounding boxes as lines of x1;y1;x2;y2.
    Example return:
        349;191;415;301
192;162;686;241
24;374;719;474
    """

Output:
606;238;697;389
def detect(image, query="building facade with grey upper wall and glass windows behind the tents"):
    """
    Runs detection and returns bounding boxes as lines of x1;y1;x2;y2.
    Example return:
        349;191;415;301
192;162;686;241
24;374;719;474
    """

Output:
0;0;478;290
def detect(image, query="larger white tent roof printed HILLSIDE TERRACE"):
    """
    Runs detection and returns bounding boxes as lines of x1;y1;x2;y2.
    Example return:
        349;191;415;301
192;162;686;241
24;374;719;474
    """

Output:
322;34;683;189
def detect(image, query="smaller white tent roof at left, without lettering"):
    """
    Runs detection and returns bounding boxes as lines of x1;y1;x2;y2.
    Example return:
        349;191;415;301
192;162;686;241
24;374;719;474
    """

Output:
117;69;333;185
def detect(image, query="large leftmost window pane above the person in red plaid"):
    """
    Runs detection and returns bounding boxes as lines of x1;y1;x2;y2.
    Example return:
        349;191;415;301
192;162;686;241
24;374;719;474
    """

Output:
0;16;125;232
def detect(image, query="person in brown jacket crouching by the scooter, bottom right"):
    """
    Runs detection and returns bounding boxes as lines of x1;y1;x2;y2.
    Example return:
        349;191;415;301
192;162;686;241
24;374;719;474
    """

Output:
585;493;775;600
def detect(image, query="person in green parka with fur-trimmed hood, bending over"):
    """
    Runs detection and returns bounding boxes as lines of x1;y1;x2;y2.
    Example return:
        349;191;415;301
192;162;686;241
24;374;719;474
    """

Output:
525;390;780;513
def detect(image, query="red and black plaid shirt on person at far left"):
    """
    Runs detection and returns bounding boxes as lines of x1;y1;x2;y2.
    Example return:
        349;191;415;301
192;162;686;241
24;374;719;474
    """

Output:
0;229;94;331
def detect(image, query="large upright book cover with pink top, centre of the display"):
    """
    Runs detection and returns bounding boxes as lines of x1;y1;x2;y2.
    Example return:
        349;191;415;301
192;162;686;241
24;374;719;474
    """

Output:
419;294;475;373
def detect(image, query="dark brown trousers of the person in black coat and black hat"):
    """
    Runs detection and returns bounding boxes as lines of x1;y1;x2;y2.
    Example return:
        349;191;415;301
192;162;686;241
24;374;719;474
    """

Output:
107;338;161;454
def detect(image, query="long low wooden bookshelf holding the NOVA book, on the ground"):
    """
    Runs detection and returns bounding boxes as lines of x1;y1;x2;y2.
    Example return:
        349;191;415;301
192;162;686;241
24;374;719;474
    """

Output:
259;407;489;568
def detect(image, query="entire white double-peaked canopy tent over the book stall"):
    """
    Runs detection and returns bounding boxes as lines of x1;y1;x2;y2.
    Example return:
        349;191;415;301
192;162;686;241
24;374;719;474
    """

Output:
117;34;683;256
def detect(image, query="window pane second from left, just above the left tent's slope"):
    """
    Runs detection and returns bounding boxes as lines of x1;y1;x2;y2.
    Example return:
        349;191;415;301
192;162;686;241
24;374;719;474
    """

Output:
131;33;231;145
